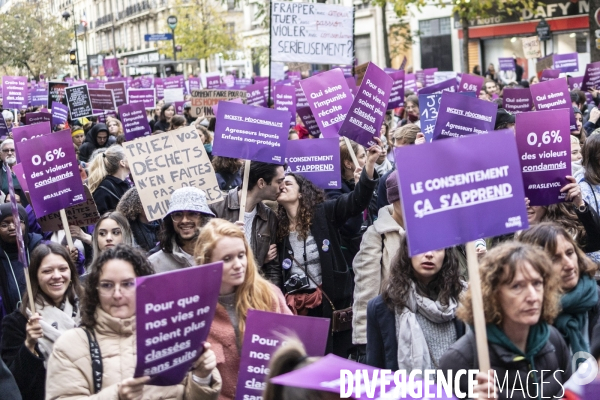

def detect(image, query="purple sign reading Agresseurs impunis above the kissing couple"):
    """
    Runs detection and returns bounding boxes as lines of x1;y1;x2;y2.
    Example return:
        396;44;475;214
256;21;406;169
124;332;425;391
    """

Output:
213;101;290;164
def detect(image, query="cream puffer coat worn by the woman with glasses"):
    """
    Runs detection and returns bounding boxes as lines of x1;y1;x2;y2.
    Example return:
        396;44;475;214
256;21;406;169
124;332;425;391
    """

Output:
46;308;221;400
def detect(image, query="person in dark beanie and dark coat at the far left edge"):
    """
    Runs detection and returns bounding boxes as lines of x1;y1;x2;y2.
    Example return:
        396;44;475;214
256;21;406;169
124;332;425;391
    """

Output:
0;203;42;334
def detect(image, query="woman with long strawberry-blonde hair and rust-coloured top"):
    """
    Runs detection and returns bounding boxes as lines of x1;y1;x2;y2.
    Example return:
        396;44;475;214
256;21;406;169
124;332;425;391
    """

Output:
194;219;292;400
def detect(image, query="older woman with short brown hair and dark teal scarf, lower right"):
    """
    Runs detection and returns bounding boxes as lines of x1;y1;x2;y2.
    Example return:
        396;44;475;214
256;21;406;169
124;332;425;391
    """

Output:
439;242;572;400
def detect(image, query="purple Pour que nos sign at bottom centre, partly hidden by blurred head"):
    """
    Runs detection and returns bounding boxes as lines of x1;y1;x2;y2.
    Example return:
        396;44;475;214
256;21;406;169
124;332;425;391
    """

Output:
234;310;328;400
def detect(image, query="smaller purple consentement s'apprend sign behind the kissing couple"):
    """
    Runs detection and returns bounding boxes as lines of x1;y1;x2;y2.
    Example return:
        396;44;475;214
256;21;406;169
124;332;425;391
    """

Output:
285;138;342;189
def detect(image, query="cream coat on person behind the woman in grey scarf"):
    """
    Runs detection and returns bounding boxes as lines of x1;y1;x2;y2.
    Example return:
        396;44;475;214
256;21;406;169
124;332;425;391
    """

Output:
352;205;404;344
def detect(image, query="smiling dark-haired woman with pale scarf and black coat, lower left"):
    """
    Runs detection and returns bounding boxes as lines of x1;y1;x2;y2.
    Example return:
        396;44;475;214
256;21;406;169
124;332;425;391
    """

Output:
0;242;81;400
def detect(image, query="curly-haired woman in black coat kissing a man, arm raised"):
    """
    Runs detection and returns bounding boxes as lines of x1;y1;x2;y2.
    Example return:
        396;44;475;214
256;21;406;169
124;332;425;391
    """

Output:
277;139;382;357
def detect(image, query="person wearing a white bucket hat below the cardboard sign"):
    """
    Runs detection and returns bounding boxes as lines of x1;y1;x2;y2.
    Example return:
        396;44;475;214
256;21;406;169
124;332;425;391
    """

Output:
149;187;215;273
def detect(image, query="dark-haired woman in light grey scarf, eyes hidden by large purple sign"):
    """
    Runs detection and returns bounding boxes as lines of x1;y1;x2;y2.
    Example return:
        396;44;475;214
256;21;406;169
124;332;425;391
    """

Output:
367;235;465;375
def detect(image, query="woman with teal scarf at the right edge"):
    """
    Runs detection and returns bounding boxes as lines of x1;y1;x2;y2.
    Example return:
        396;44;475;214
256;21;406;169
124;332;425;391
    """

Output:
519;223;600;354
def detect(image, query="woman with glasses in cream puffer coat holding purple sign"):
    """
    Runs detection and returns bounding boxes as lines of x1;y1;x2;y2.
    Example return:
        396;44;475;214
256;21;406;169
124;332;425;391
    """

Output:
46;245;221;400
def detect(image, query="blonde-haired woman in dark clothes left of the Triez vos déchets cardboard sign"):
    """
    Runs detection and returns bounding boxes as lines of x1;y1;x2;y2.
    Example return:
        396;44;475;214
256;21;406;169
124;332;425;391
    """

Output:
87;145;130;215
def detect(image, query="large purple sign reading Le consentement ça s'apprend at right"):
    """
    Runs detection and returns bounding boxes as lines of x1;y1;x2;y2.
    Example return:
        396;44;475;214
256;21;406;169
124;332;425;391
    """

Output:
394;131;528;257
